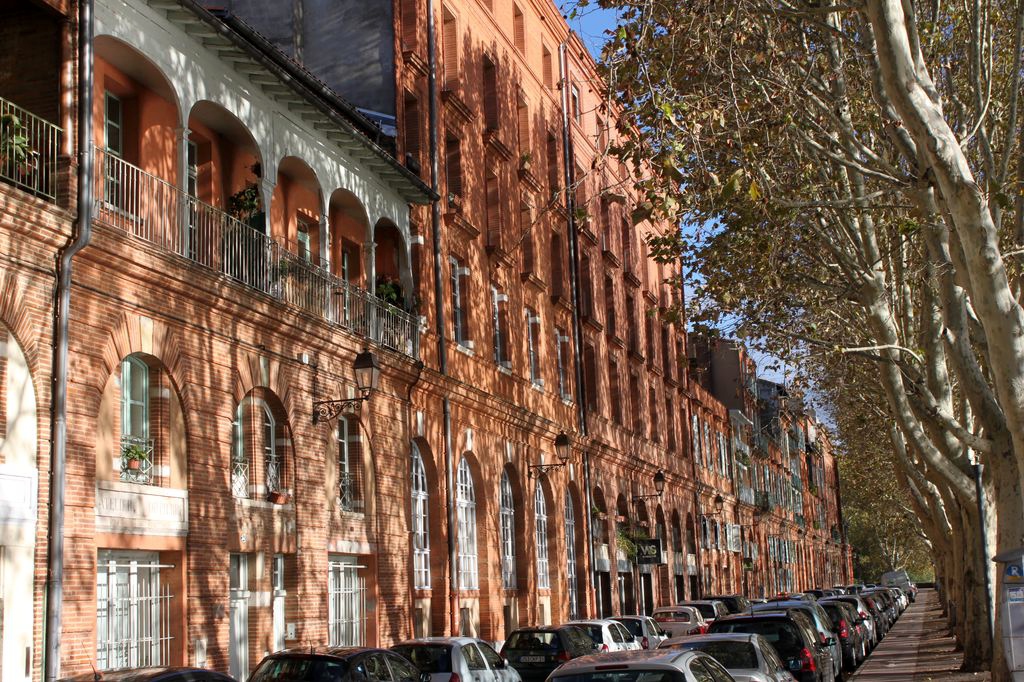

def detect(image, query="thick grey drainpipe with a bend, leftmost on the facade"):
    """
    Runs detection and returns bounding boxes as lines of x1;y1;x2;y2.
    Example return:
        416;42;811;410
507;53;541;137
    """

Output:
43;0;93;682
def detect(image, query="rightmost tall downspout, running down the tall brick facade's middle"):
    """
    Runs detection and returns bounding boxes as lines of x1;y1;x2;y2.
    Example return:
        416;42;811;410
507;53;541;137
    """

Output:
558;38;601;617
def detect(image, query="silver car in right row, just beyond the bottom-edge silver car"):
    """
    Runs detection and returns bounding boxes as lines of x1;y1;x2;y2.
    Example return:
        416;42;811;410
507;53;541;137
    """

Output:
660;633;793;682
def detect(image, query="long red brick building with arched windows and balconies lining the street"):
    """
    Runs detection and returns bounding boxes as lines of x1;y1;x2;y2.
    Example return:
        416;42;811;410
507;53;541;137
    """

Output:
0;0;847;682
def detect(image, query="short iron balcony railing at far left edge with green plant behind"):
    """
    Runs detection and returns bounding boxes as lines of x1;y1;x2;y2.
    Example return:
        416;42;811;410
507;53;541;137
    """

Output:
0;97;63;201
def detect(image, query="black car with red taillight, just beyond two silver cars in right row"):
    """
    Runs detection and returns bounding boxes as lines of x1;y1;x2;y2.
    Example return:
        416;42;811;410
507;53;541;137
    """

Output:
708;609;834;682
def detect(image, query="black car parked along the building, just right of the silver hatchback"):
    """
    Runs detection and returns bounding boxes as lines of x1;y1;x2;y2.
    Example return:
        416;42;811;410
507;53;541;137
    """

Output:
502;626;597;682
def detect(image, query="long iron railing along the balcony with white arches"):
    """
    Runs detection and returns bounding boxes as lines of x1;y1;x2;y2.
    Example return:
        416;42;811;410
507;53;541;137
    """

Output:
95;148;419;357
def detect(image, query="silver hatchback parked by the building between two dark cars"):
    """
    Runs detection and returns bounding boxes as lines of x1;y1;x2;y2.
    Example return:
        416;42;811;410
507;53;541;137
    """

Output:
391;637;522;682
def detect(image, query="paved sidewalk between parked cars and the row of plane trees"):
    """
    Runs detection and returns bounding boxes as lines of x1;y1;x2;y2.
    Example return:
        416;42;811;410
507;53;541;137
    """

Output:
850;590;990;682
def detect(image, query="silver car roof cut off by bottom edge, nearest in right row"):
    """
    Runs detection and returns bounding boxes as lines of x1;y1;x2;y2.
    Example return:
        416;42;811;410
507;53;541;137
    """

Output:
548;649;734;682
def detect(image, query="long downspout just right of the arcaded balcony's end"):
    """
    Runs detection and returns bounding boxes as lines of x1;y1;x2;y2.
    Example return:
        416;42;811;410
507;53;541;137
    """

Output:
427;0;459;635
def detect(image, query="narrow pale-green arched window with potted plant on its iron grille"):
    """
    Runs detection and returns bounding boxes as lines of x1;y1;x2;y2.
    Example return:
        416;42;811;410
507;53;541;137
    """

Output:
121;355;153;483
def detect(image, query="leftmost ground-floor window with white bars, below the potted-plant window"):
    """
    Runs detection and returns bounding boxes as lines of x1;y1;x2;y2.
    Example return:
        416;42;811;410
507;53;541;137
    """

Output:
96;550;173;670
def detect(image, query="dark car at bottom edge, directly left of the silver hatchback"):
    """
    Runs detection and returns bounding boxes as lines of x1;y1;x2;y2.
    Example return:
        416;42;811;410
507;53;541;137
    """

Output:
249;646;420;682
